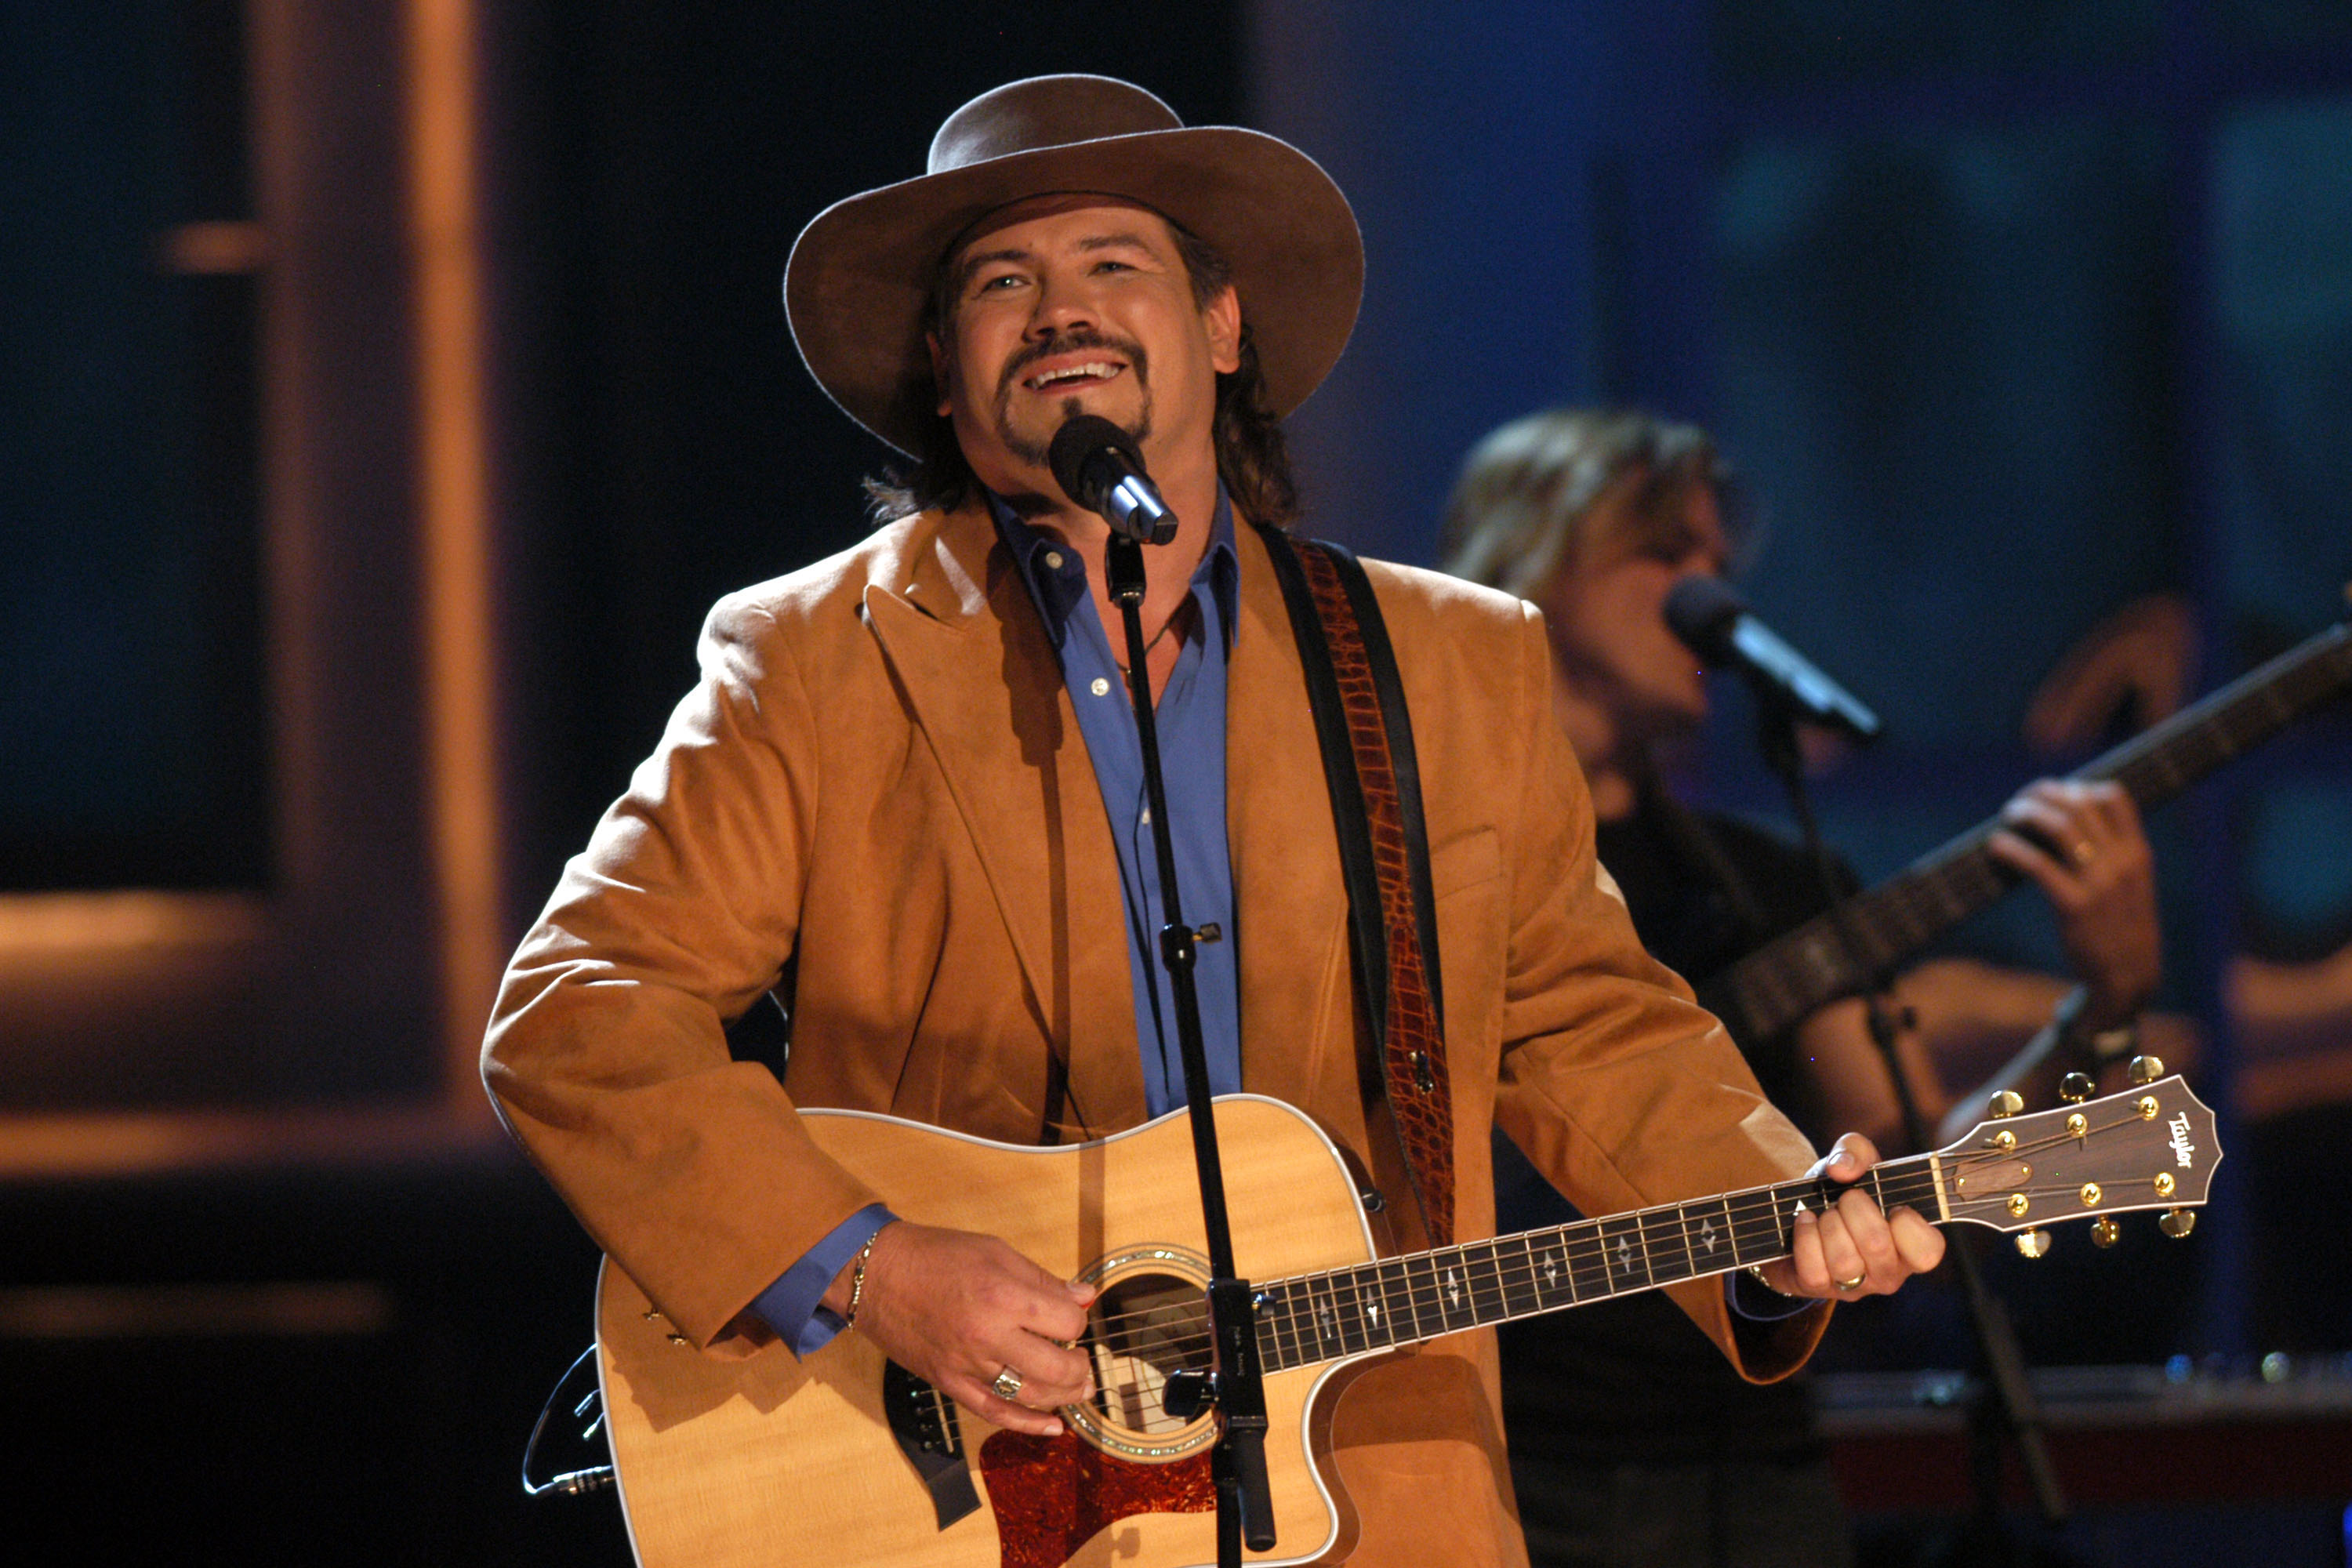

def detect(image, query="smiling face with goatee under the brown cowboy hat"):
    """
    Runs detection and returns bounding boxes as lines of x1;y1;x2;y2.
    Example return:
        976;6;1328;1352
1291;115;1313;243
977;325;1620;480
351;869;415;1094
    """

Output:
931;195;1240;496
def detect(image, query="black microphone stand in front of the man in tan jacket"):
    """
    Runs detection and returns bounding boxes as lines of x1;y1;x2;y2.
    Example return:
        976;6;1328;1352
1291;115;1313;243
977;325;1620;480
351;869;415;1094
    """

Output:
1105;527;1275;1568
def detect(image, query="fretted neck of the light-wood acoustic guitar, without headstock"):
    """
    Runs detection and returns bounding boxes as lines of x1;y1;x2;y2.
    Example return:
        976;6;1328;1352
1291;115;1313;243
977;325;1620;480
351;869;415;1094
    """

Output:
1256;1154;1943;1373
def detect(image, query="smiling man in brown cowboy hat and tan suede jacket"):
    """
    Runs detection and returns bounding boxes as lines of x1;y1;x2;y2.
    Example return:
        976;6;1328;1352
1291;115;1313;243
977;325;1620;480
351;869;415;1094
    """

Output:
485;75;1940;1563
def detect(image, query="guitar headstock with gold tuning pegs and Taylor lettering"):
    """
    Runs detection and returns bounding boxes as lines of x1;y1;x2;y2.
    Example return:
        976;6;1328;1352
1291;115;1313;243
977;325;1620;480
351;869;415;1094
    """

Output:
1936;1074;2220;1246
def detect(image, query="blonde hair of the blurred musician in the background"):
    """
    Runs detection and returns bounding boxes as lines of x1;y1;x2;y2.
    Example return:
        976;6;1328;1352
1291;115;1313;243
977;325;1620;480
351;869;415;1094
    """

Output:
1439;409;1736;600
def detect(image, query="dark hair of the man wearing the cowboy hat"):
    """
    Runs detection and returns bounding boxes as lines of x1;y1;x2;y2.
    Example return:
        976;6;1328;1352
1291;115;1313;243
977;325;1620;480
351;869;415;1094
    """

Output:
866;219;1298;527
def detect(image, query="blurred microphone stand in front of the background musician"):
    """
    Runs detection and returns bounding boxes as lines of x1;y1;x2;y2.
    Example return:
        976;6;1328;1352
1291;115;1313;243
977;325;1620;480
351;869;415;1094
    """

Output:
1750;700;2067;1561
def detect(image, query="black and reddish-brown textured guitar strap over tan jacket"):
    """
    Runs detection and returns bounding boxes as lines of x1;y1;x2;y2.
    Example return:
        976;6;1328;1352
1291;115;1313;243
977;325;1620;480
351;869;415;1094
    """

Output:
1258;527;1454;1246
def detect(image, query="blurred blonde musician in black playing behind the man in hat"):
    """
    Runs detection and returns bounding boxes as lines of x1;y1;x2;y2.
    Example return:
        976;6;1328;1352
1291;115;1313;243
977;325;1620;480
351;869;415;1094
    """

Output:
1446;412;2159;1566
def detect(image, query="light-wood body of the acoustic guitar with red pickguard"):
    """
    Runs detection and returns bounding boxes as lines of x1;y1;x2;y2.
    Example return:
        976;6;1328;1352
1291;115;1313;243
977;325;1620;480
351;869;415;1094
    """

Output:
597;1095;1374;1568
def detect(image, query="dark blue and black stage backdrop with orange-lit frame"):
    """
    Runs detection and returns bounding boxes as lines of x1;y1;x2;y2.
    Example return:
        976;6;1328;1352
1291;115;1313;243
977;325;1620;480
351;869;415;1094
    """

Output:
0;0;2352;1566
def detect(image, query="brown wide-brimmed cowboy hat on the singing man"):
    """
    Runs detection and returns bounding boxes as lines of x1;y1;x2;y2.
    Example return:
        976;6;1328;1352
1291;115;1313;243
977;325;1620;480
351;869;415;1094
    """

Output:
783;75;1364;452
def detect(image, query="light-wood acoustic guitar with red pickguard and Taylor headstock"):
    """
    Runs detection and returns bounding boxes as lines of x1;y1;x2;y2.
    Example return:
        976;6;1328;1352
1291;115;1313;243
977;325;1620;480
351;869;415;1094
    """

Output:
597;1076;2220;1568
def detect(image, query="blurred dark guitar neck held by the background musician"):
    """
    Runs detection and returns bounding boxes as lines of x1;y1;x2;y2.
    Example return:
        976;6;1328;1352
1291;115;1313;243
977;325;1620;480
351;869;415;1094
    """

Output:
1698;626;2352;1039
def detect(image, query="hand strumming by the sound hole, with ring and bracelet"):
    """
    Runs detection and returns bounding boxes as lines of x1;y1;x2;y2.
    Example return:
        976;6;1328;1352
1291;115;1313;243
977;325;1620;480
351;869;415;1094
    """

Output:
826;1220;1094;1436
